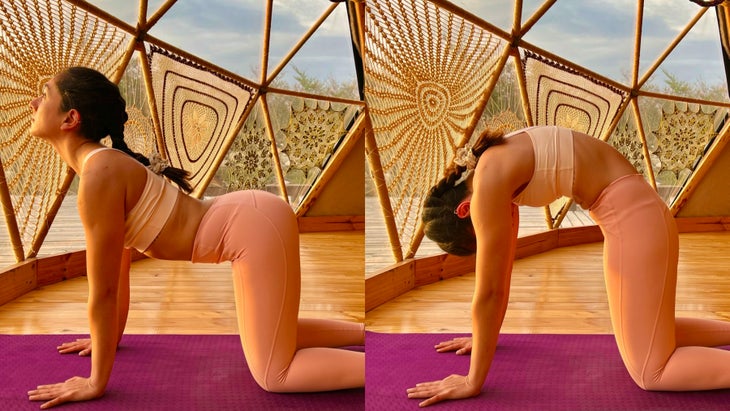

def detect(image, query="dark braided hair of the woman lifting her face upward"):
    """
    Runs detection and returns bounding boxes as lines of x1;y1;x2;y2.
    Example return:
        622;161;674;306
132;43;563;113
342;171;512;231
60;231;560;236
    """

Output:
56;67;193;193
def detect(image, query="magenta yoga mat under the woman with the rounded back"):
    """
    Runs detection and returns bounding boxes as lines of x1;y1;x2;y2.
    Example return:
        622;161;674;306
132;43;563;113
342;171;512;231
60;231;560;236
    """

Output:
365;332;730;411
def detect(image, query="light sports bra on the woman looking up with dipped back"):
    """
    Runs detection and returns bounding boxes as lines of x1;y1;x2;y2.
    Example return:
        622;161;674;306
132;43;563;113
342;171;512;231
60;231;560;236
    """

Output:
84;147;179;252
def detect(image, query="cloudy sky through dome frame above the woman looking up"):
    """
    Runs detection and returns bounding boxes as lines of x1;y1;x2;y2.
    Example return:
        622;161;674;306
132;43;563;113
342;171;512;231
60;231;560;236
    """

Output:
89;0;356;85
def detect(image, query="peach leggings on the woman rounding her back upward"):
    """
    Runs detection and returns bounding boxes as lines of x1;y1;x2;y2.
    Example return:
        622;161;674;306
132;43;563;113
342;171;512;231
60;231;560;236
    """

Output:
590;175;730;391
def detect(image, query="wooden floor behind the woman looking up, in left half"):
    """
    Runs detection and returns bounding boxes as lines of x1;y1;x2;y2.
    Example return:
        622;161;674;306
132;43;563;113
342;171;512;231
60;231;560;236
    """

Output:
0;231;365;334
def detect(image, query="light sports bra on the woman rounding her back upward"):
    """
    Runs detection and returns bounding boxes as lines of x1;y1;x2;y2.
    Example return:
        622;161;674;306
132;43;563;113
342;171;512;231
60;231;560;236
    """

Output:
505;126;575;207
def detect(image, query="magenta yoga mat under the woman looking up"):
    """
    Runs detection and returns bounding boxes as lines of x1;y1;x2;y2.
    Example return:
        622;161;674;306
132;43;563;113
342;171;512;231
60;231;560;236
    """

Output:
0;335;365;411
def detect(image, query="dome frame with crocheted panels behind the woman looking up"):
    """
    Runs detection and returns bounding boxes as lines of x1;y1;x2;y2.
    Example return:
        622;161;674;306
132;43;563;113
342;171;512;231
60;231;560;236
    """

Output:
0;0;363;268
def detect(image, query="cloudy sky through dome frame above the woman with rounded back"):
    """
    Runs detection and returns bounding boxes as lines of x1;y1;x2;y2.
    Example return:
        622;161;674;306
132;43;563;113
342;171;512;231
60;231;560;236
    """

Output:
456;0;724;82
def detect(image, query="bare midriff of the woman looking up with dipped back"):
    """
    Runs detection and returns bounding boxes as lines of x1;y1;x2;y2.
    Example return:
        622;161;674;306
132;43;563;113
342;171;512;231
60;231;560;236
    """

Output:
144;193;212;261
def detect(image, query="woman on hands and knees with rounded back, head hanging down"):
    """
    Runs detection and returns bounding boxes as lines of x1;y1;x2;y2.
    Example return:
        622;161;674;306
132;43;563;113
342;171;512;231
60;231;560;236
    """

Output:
408;126;730;406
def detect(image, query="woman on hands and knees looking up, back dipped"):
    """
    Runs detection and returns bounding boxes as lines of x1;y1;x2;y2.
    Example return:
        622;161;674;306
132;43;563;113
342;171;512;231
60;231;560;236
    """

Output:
28;67;365;408
